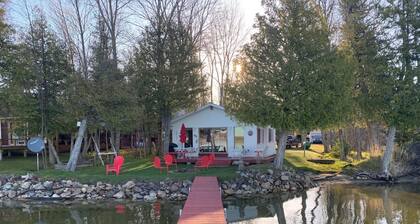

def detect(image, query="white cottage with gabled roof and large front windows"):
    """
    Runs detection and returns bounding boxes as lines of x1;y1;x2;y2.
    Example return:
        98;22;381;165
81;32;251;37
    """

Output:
170;104;276;158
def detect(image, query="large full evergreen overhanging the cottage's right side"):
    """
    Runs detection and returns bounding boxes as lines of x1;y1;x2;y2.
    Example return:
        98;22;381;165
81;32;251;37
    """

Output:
226;0;348;169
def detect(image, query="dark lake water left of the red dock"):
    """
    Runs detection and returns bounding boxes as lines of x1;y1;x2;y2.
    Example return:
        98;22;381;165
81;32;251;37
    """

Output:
0;201;181;224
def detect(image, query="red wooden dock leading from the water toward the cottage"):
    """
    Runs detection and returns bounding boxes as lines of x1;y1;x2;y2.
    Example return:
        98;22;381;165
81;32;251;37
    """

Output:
178;177;226;224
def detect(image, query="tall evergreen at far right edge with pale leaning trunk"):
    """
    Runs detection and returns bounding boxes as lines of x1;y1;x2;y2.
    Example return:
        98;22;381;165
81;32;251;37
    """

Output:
381;0;420;175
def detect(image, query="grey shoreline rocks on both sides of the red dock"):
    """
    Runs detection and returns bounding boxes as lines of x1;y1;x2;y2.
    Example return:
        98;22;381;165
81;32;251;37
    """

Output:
0;169;317;202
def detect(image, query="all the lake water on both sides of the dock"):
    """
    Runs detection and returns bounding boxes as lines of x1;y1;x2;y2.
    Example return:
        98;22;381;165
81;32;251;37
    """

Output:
0;184;420;224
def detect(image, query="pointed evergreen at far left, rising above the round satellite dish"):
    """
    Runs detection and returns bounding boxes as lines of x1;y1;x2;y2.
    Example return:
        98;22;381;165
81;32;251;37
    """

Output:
5;10;72;163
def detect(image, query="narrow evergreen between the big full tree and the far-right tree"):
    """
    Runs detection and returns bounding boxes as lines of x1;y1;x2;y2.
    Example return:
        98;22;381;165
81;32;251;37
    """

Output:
340;0;387;159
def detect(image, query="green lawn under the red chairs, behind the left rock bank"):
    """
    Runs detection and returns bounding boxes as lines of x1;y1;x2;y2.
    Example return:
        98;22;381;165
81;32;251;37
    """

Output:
0;156;237;183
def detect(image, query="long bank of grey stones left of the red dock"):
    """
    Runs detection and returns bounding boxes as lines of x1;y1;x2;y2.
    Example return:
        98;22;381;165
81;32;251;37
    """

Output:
0;175;191;201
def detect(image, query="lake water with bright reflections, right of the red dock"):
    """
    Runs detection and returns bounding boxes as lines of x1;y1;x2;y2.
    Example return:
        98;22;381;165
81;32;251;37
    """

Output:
224;185;420;224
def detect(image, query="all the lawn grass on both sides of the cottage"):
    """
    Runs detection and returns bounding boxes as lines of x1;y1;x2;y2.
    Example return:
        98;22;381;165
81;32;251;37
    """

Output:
0;144;380;183
